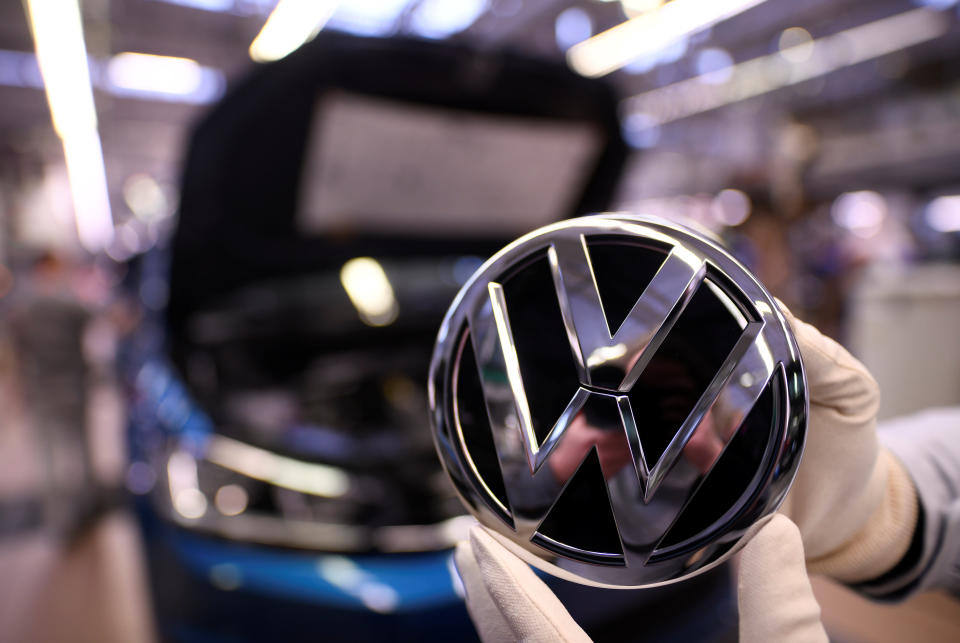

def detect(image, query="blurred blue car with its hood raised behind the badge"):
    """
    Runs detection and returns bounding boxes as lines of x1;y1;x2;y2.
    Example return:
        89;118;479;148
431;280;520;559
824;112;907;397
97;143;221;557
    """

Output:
120;33;626;641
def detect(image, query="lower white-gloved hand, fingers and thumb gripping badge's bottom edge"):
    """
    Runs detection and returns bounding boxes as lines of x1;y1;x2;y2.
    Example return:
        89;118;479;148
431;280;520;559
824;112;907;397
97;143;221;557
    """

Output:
456;515;827;643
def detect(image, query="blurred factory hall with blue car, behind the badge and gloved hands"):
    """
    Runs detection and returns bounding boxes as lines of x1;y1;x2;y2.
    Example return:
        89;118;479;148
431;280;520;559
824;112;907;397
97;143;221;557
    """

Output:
0;0;960;641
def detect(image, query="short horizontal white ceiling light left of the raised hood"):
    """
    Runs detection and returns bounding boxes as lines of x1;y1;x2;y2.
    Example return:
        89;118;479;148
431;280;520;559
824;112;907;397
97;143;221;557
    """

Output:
107;51;224;103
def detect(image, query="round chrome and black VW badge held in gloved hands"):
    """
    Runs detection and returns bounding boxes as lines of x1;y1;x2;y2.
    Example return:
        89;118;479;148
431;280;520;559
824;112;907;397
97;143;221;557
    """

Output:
430;214;807;587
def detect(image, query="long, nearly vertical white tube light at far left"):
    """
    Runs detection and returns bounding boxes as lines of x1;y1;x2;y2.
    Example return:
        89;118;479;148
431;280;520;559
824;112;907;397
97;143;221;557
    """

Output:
27;0;113;252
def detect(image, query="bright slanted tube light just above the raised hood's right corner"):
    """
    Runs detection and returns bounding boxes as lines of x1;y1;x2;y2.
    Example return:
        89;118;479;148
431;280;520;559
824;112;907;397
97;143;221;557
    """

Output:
567;0;764;77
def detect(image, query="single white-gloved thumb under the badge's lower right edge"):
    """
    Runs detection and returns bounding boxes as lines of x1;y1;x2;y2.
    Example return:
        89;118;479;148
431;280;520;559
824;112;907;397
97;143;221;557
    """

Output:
737;514;828;643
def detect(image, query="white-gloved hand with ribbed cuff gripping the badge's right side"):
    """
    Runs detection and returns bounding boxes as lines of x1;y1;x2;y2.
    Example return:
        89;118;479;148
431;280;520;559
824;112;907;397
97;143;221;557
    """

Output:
780;305;917;583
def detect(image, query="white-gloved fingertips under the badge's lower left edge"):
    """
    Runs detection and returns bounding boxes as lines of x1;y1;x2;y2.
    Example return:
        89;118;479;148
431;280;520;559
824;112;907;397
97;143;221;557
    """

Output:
456;527;590;643
